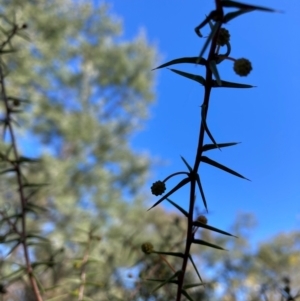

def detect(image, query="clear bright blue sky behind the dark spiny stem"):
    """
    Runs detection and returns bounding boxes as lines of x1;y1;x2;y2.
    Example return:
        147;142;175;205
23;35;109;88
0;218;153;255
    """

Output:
107;0;300;242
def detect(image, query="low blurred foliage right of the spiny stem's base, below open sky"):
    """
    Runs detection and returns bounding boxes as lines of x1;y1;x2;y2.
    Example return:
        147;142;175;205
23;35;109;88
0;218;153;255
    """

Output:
193;214;300;301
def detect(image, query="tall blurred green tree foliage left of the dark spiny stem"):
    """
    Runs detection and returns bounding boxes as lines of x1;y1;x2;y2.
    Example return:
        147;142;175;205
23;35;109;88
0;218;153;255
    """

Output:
0;0;178;300
